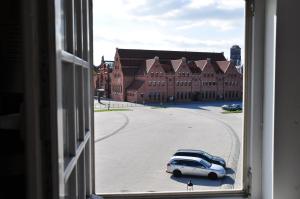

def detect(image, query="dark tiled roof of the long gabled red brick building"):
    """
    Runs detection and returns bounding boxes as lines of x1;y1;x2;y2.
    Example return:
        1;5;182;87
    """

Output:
117;49;229;75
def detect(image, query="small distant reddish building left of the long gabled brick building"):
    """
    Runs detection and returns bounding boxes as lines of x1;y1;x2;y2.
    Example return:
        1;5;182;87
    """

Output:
95;56;114;98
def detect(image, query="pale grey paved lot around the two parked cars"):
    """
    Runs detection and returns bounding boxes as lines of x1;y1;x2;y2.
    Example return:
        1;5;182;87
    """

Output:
95;101;243;193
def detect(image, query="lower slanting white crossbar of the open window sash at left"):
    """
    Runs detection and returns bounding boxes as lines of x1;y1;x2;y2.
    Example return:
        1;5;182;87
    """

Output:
64;131;91;183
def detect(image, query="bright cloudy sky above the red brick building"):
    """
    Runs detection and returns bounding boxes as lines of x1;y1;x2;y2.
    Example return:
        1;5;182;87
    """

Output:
93;0;245;66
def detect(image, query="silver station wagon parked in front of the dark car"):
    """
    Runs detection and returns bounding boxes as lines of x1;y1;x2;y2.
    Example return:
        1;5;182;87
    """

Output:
167;156;226;179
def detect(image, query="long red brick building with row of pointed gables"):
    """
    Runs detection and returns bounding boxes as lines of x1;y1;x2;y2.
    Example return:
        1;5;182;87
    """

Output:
111;49;243;103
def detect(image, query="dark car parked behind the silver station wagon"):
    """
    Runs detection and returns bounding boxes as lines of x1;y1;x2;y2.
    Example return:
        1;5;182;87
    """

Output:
174;149;226;168
